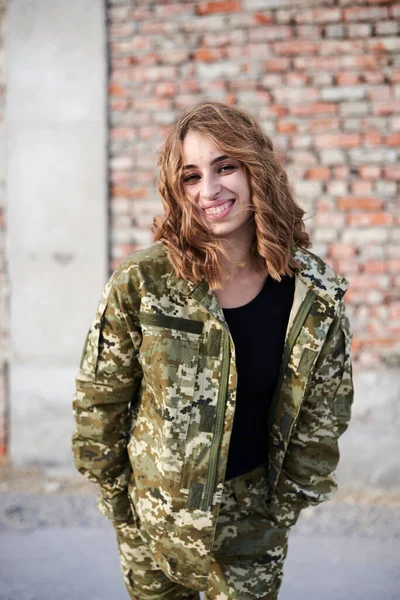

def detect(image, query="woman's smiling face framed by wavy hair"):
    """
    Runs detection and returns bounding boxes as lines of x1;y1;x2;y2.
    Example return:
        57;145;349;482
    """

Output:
183;131;254;244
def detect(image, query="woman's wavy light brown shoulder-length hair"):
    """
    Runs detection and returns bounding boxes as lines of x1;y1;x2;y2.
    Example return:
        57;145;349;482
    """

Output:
153;101;311;289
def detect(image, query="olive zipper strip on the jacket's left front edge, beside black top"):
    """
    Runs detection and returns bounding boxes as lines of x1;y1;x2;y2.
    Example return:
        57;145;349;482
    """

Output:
201;332;230;511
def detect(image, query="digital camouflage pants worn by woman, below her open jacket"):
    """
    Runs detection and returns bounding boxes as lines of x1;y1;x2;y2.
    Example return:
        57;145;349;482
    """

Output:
116;467;289;600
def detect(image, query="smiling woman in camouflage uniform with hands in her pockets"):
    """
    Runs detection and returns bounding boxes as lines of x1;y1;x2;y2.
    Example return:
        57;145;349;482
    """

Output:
73;102;352;600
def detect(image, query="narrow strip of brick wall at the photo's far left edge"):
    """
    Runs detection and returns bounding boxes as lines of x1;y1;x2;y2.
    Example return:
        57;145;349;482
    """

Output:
0;0;8;462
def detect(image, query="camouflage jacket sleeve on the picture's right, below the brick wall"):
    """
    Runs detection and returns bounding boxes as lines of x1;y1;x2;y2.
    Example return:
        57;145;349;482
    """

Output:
269;303;353;526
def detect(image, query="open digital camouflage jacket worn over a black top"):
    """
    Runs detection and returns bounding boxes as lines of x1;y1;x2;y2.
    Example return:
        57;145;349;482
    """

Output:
73;243;352;590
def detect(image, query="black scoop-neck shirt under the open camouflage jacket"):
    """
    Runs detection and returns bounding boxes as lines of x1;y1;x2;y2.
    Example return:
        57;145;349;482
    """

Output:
223;276;294;479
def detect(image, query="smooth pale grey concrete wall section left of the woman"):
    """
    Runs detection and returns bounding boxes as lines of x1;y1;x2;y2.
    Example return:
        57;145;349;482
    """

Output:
6;0;108;465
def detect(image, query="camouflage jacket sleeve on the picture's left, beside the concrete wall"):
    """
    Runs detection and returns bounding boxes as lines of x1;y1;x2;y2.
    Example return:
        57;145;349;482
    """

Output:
72;273;142;521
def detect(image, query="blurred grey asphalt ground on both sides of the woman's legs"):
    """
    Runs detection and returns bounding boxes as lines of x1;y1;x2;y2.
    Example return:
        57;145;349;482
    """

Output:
0;469;400;600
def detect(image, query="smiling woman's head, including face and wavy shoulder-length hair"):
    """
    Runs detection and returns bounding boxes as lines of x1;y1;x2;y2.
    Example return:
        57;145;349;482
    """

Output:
155;102;311;289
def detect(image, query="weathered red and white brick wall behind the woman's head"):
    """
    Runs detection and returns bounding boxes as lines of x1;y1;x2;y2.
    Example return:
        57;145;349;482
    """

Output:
108;0;400;368
